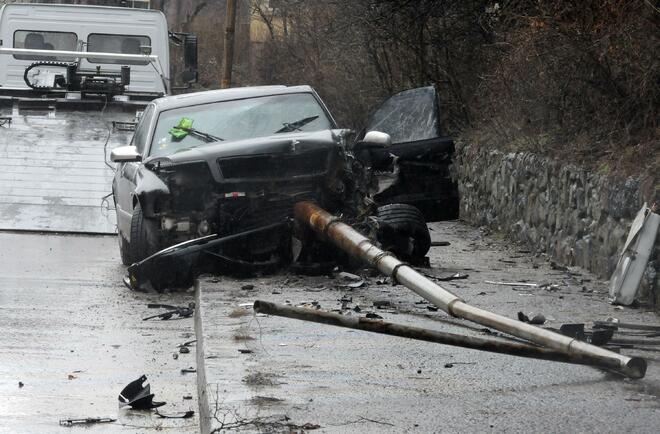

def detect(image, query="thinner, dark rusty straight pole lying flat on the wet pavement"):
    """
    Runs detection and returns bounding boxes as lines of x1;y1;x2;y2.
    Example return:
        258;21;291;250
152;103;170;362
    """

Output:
254;300;619;370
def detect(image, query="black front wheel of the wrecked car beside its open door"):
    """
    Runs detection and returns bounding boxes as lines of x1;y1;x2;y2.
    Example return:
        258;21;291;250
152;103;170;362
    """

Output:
376;203;431;263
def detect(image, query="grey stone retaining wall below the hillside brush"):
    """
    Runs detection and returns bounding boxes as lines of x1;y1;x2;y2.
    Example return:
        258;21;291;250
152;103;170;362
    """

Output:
454;145;660;303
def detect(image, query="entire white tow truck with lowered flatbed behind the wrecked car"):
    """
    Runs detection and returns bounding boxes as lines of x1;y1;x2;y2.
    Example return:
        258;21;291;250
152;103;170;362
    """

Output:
0;4;197;233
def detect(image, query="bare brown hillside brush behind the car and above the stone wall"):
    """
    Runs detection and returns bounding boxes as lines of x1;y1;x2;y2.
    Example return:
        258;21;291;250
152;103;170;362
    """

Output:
244;0;660;188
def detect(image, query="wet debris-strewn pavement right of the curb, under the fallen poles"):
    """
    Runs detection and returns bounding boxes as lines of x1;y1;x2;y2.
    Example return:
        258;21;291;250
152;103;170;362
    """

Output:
198;222;660;433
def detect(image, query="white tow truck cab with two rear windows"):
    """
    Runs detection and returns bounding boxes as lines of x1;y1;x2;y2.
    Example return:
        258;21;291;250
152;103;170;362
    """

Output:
0;4;196;96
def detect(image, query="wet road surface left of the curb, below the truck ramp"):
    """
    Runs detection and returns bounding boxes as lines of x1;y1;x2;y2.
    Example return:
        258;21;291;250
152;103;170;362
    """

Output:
0;232;199;433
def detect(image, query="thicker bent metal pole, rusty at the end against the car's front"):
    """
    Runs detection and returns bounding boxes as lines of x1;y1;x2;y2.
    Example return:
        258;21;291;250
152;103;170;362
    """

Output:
294;202;646;378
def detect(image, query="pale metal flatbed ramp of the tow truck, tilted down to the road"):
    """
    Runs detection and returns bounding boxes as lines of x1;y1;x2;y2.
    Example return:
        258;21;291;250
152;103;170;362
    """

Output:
0;100;135;234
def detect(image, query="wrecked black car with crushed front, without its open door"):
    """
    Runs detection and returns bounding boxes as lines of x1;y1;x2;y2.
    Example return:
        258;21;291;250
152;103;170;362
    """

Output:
111;86;451;289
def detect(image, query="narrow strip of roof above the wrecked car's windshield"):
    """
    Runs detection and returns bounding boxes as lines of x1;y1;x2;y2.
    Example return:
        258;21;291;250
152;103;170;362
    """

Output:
153;85;314;112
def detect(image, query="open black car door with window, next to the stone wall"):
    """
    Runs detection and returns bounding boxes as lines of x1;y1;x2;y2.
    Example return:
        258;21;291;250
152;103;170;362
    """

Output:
365;86;458;221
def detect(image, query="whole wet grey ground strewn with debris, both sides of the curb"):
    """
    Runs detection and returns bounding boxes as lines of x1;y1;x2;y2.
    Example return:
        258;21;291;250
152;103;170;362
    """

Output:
0;222;660;433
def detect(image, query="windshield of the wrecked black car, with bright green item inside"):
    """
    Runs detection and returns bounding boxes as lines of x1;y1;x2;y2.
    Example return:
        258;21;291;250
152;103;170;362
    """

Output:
150;93;332;156
